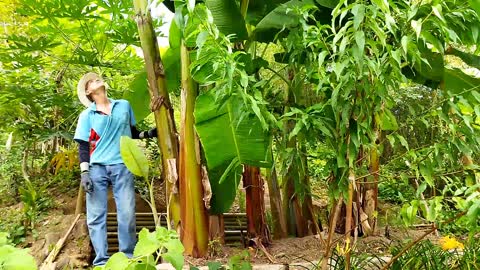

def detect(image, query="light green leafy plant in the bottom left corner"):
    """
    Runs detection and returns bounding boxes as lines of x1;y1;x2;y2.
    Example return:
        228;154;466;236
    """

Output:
0;232;37;270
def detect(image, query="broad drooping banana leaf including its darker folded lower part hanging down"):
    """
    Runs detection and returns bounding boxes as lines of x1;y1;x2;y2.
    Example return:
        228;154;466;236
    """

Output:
195;93;271;214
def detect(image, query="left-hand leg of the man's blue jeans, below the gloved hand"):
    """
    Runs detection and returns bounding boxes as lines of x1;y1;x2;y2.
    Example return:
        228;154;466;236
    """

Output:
87;165;108;265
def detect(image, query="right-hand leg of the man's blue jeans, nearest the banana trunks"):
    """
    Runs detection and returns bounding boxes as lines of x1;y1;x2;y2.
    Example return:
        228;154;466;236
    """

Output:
108;164;137;257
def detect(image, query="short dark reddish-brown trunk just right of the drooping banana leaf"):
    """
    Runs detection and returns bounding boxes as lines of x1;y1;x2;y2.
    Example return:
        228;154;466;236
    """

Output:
242;165;271;245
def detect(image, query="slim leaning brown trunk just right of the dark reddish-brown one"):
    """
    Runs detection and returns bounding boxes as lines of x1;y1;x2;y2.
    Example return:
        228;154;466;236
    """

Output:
267;167;287;239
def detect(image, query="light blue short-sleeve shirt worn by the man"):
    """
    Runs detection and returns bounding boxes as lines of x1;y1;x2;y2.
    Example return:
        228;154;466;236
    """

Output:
74;99;136;165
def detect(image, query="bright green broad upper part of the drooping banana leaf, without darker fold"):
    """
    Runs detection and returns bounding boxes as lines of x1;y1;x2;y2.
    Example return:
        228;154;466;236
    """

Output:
195;94;270;168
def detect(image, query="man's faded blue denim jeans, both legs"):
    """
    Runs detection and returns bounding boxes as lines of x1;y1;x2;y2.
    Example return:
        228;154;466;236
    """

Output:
87;164;136;265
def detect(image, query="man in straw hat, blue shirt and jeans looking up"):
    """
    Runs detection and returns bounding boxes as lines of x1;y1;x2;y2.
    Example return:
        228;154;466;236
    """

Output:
74;73;158;265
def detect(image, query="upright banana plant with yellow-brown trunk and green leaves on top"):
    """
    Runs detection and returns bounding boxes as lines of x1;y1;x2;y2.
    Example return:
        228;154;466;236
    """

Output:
170;0;209;257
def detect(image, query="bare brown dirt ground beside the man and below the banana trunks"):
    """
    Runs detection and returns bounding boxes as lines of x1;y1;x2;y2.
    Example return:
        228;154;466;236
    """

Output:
20;192;438;269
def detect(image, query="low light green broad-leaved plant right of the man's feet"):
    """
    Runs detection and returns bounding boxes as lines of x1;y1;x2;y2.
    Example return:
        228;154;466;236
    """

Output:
94;226;184;270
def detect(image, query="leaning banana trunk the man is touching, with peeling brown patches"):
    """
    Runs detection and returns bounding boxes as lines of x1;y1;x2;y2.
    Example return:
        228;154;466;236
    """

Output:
133;0;180;231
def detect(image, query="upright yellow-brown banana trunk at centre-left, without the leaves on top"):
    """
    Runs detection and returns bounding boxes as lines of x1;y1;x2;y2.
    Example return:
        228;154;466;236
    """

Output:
180;41;208;257
